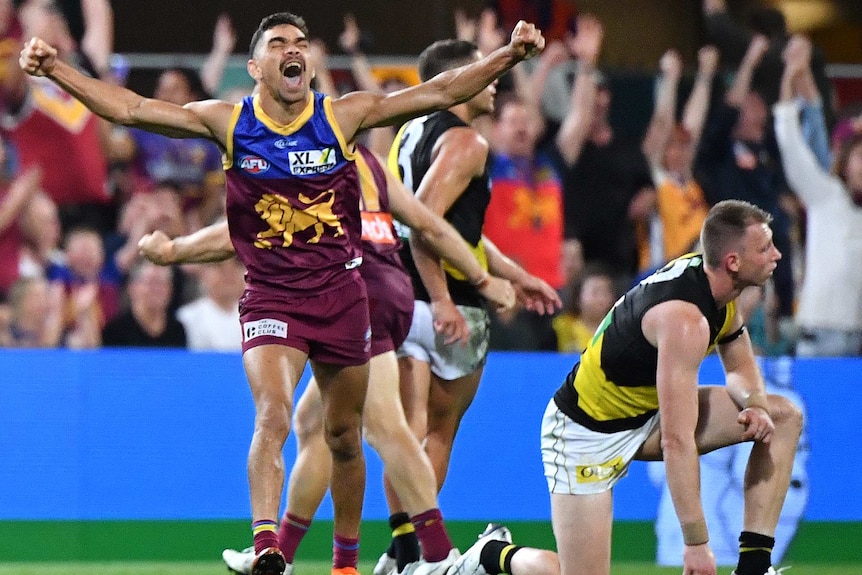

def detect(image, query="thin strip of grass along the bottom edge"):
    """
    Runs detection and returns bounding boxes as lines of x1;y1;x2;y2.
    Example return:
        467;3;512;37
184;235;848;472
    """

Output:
0;561;862;575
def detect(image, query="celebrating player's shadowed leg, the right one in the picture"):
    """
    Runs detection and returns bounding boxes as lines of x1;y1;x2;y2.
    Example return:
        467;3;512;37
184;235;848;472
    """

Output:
318;360;368;569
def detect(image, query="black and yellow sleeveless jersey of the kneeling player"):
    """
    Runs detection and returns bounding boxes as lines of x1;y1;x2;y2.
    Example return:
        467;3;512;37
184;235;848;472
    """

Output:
554;254;736;433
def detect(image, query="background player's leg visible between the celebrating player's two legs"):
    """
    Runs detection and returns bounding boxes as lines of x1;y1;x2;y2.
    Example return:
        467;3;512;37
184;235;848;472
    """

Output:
278;378;332;563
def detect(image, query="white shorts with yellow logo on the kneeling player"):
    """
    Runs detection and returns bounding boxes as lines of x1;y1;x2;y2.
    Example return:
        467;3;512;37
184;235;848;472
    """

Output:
542;398;659;495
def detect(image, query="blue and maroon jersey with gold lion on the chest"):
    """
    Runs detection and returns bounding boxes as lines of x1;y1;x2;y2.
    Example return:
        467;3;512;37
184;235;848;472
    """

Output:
224;92;362;295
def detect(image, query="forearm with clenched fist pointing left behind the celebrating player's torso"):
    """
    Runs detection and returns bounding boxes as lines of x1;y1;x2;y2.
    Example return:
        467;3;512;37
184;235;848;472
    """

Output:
138;220;236;266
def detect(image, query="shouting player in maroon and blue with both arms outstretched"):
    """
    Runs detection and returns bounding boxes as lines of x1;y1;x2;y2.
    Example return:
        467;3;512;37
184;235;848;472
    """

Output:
19;12;544;575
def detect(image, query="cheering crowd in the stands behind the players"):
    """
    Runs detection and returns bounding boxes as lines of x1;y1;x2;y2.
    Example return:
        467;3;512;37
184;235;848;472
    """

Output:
0;0;862;356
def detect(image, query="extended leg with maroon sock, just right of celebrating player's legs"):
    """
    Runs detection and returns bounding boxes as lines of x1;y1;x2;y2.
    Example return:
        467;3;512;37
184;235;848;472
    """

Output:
363;351;452;569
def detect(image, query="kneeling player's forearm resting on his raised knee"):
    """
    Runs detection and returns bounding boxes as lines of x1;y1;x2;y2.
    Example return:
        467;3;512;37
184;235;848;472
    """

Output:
718;315;775;443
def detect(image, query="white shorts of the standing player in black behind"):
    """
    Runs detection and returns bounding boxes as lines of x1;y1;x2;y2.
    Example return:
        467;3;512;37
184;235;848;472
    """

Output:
398;300;490;381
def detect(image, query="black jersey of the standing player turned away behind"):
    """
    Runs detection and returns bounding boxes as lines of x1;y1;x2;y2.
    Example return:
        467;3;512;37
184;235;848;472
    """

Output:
389;110;491;307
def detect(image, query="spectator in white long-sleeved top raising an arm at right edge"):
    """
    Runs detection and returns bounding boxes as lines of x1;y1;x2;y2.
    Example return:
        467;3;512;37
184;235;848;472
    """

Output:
774;36;862;356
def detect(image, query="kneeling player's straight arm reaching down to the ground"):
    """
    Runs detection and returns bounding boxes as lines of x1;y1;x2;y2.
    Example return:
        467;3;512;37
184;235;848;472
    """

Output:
642;300;716;575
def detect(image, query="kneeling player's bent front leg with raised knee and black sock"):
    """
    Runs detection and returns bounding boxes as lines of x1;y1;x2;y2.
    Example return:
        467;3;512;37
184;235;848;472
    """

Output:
639;386;802;575
